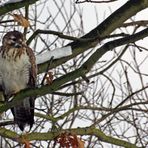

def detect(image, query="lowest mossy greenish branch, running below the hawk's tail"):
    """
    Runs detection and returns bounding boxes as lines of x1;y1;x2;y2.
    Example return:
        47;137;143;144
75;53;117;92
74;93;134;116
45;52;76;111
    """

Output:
0;127;141;148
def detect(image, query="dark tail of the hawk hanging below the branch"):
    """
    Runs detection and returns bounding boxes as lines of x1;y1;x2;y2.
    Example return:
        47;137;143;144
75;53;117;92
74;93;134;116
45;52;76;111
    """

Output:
11;97;34;131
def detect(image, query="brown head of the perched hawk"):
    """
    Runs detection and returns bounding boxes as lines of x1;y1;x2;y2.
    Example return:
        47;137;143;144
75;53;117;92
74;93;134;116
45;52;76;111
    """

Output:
2;31;26;48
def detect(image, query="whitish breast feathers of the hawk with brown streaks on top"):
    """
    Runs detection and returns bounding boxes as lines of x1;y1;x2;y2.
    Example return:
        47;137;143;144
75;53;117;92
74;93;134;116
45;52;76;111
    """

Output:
0;48;31;94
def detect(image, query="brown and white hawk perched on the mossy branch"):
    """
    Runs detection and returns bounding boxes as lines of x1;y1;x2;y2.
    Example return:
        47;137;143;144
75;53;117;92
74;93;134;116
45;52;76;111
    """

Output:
0;31;37;131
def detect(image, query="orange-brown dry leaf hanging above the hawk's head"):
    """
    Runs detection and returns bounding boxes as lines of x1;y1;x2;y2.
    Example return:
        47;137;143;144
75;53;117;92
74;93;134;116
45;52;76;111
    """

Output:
12;14;30;28
